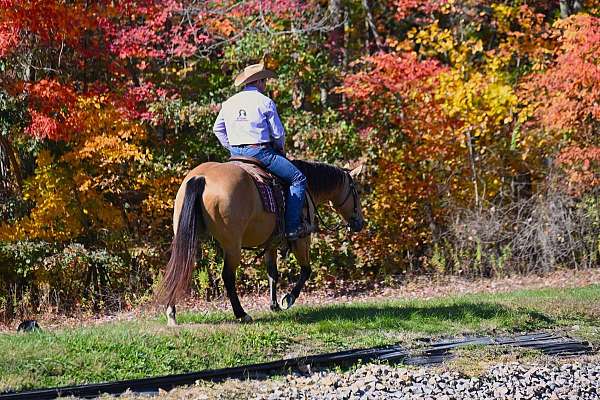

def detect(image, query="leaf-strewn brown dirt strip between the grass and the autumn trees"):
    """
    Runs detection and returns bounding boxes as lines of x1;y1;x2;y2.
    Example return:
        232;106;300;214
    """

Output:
0;269;600;332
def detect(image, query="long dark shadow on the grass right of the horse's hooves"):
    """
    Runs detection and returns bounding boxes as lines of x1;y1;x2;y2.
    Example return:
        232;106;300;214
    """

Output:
259;302;555;330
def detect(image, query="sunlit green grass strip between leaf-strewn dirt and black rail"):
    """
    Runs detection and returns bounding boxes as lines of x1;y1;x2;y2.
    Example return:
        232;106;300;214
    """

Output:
0;285;600;391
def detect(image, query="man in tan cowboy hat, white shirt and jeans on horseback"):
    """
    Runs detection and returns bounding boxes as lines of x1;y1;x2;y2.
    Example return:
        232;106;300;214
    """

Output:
213;64;308;241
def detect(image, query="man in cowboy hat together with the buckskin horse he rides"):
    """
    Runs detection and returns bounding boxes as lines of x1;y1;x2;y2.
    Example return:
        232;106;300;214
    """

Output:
157;64;364;325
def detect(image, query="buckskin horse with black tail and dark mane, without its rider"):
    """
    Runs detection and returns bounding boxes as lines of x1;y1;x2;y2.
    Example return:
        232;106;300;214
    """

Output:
157;160;365;326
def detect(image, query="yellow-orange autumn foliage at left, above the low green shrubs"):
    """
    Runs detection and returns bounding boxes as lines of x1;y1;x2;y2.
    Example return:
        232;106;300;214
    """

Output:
0;96;150;241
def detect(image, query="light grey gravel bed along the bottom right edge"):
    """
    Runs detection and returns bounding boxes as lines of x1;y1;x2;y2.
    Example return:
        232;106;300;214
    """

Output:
237;363;600;400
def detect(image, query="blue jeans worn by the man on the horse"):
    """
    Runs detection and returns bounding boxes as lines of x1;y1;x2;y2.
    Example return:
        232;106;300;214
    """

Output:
229;146;306;233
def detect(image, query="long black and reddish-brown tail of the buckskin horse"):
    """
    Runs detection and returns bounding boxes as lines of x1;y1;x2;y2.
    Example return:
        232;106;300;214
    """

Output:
157;176;206;305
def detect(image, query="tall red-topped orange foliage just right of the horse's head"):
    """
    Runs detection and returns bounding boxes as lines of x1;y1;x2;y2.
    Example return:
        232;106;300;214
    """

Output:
340;53;460;261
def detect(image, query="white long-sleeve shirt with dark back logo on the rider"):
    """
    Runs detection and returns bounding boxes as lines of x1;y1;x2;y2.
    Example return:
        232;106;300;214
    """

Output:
213;86;285;149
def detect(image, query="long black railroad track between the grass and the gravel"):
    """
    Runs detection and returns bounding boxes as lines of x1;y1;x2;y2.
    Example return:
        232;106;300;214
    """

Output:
0;333;593;400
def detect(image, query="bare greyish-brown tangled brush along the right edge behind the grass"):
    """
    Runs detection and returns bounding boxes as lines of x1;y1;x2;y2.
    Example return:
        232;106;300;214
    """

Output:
436;183;600;276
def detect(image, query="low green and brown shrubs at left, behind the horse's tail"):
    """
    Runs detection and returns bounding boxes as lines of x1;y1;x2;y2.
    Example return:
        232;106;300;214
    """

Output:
0;241;161;318
